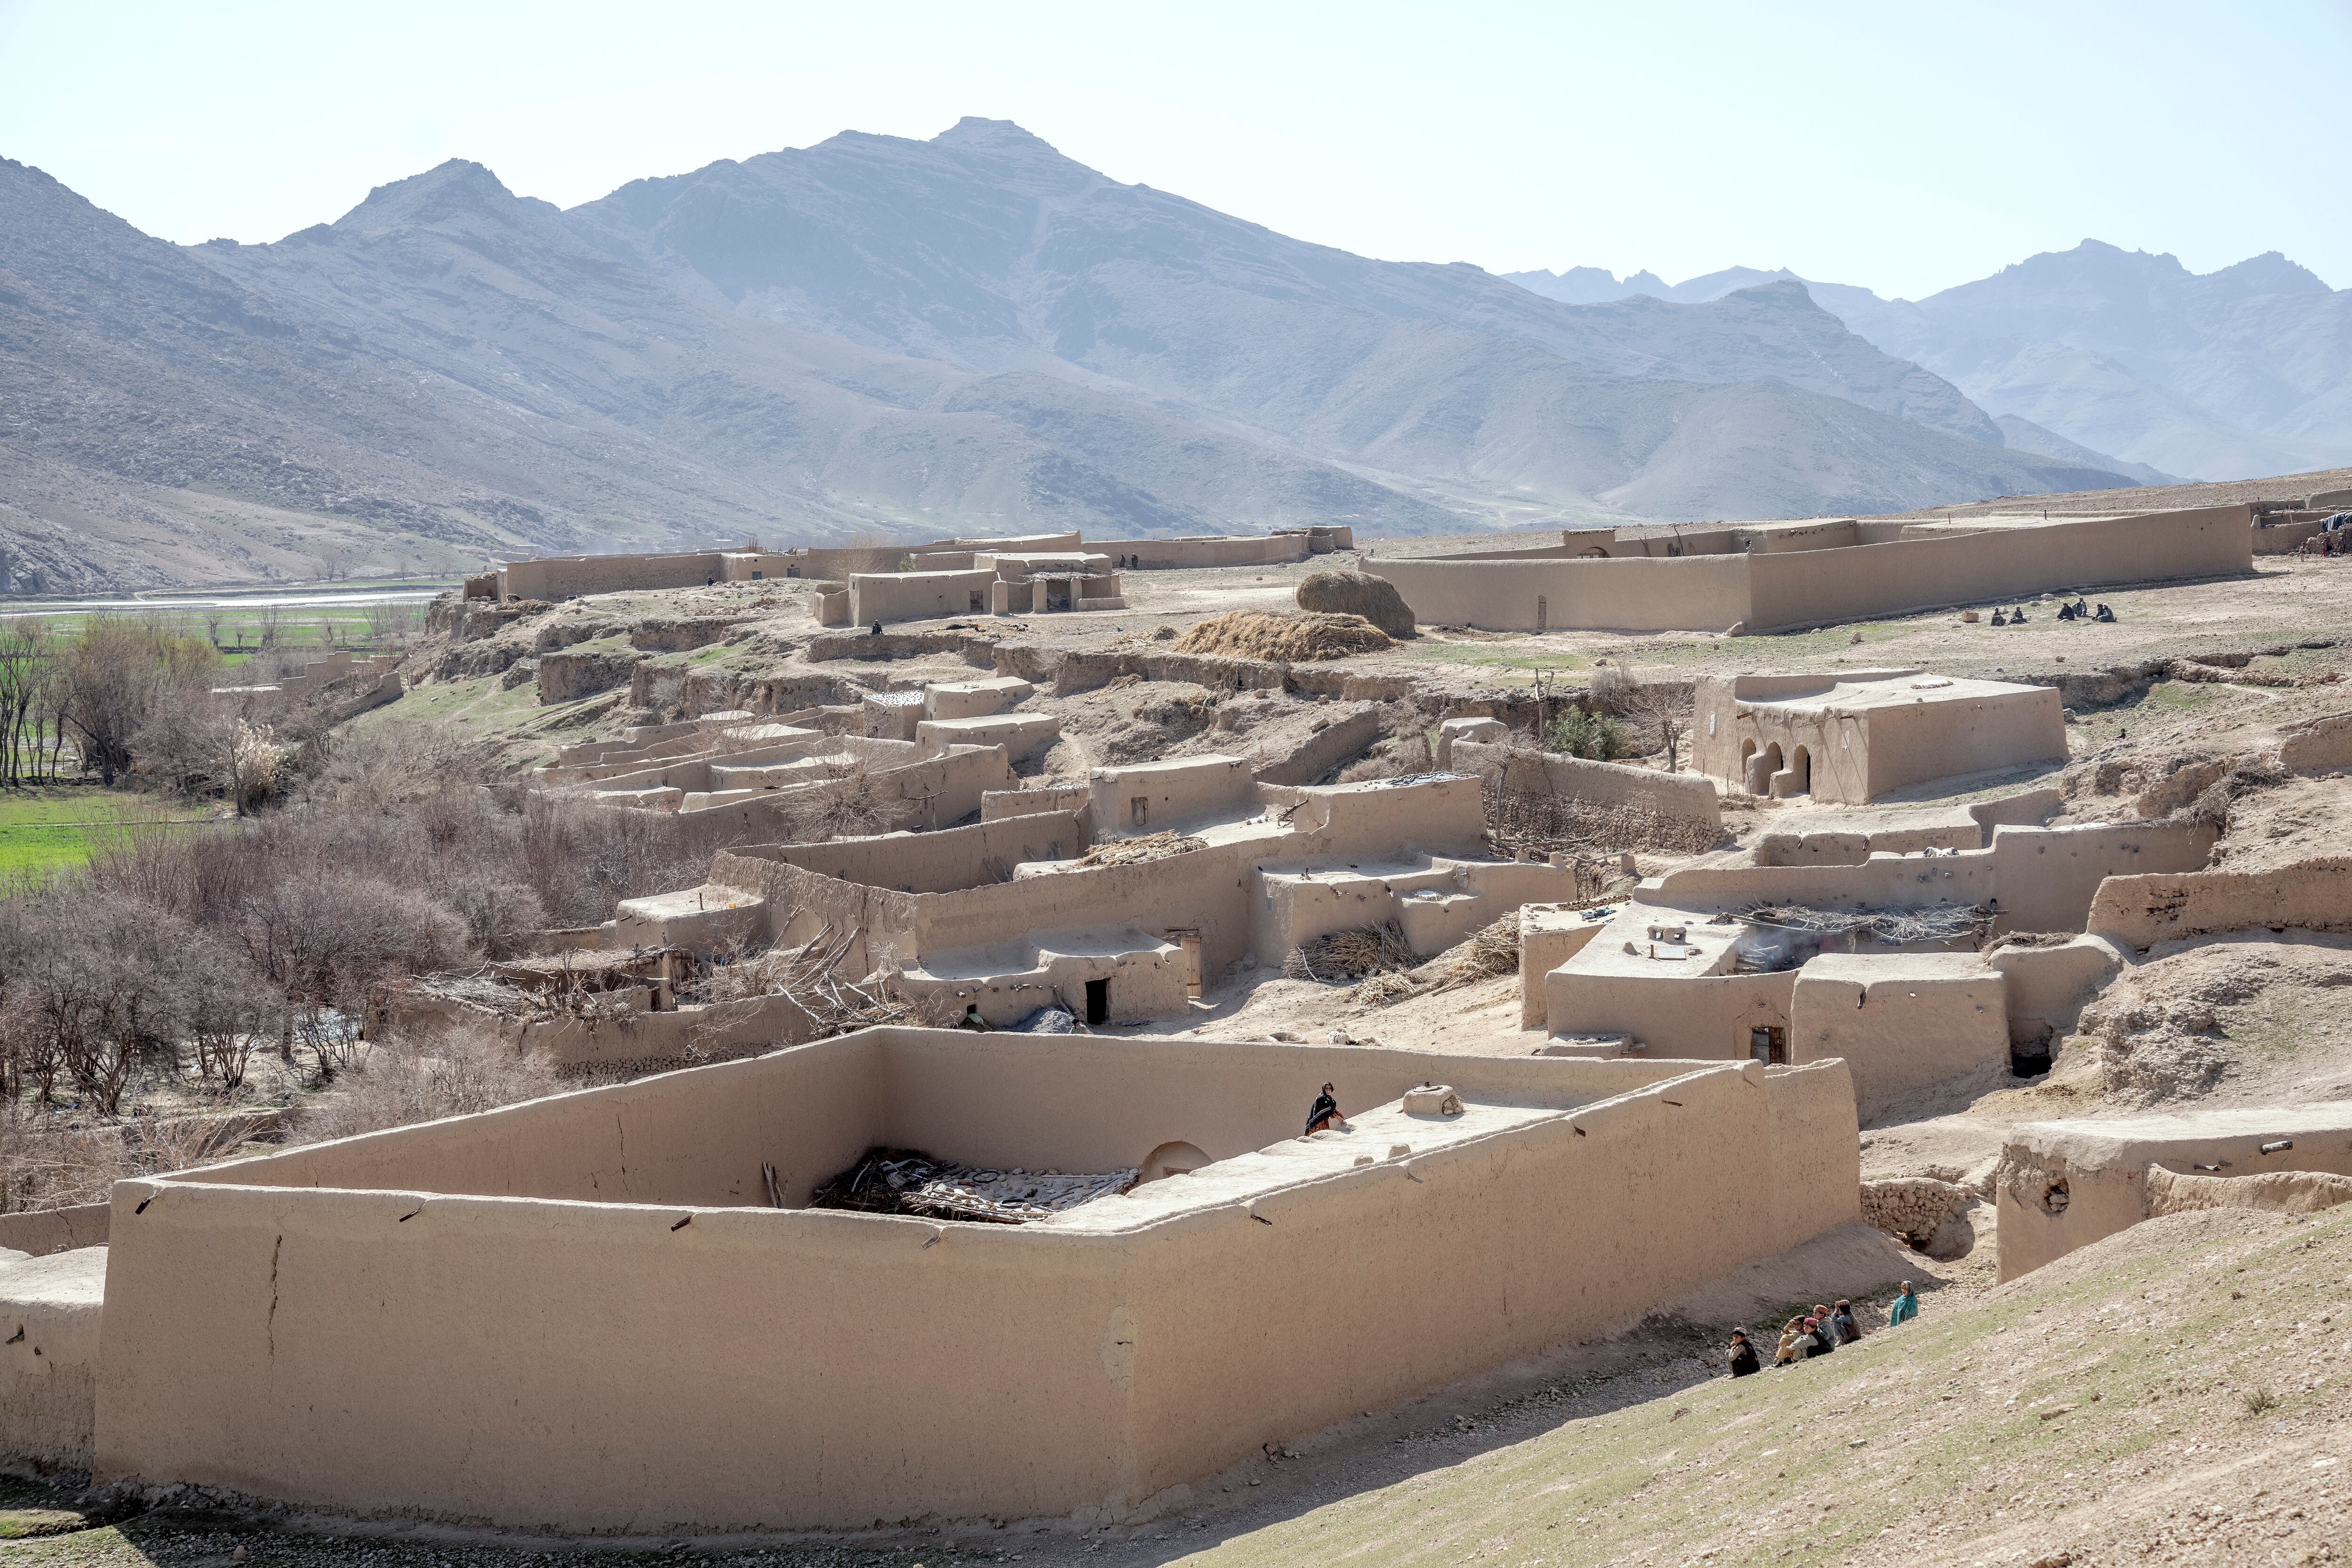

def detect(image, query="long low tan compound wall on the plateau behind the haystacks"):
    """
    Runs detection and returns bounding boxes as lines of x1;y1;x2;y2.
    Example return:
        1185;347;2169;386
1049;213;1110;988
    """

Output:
1364;506;2253;633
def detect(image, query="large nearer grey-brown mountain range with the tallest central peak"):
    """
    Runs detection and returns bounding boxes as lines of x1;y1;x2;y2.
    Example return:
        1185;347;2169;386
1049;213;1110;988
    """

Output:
0;120;2140;590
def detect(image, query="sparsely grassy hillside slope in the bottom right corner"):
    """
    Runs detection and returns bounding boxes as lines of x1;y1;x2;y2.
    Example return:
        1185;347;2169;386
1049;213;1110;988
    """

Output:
1185;1211;2352;1568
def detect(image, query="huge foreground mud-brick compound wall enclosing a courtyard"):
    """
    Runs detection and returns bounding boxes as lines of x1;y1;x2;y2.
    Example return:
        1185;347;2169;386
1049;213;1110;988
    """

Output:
96;1029;1858;1533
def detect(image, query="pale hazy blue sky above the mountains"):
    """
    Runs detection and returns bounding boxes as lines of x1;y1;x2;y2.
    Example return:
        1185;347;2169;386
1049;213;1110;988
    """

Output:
0;0;2352;296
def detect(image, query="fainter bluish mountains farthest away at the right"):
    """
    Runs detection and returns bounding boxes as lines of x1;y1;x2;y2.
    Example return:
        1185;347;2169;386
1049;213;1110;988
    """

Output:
1510;240;2352;484
